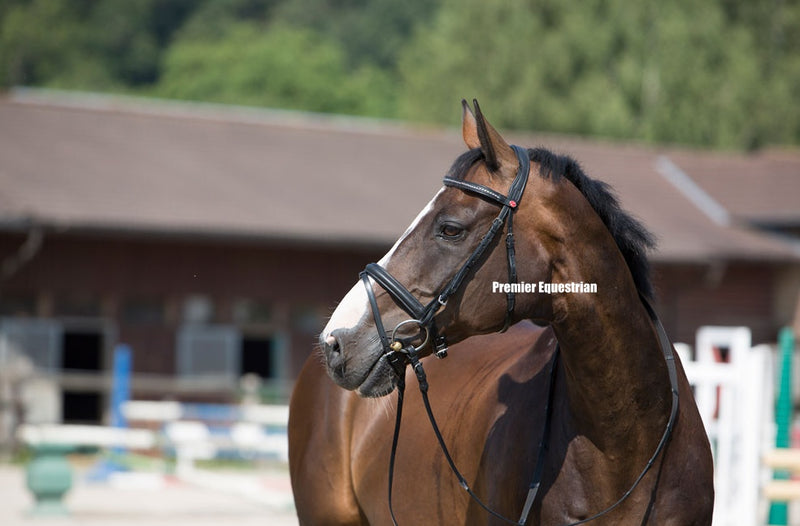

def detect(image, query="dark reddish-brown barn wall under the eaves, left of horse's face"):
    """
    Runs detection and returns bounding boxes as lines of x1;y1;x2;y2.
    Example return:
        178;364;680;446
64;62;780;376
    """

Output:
0;234;385;414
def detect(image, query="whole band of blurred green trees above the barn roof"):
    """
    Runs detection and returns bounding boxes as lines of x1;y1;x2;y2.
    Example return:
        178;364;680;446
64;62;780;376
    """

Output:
0;0;800;148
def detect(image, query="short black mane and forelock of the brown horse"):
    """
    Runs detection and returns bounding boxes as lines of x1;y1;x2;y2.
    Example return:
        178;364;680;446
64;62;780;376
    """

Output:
448;148;655;299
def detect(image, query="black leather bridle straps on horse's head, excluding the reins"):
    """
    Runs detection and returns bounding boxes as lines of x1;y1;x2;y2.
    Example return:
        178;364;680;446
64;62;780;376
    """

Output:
359;146;530;375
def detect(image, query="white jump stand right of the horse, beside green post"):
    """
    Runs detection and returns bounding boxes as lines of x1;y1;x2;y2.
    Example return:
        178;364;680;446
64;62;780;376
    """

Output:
675;327;786;526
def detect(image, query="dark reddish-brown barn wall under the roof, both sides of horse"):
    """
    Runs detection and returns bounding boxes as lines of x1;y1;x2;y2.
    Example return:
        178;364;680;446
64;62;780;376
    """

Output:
0;233;798;422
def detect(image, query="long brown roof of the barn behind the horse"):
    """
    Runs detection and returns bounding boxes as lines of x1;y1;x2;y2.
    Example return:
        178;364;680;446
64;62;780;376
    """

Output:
0;91;800;261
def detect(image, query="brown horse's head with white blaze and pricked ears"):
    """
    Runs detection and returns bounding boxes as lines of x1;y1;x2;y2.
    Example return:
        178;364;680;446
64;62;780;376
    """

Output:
320;101;576;396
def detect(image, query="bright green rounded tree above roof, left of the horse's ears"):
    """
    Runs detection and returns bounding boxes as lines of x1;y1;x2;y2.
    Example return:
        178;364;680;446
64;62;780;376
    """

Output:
155;23;393;115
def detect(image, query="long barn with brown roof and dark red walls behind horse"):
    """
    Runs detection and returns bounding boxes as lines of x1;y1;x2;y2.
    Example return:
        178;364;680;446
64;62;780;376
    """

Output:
0;91;800;422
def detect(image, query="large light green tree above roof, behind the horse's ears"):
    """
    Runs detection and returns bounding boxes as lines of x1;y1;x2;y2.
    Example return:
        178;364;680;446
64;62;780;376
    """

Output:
400;0;797;147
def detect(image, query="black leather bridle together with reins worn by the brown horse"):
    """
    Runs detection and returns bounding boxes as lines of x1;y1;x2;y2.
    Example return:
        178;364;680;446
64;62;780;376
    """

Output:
359;145;678;526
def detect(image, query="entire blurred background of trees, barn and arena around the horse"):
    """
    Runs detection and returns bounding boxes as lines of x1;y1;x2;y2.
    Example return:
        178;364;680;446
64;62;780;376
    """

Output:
0;0;800;525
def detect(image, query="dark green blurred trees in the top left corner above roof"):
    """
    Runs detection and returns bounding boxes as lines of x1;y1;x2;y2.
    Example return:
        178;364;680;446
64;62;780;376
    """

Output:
0;0;194;90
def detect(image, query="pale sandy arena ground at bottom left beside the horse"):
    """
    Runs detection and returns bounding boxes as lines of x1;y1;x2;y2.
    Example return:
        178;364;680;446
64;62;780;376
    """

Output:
0;465;297;526
